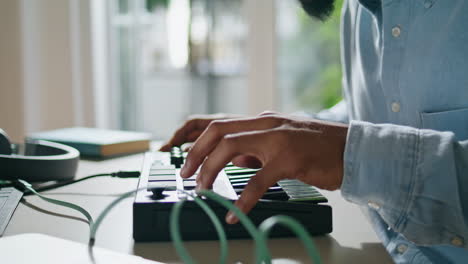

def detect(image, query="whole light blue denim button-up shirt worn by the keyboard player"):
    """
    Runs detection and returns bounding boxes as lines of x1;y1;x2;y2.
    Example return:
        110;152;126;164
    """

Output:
319;0;468;263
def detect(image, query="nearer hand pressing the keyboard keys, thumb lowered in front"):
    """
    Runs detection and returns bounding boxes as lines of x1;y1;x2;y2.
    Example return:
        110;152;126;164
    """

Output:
181;115;348;224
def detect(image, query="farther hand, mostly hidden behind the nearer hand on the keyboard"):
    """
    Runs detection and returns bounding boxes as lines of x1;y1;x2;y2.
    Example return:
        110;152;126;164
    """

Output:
159;114;240;151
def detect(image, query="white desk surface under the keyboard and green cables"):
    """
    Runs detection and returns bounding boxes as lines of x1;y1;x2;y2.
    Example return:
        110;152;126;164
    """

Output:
4;154;393;264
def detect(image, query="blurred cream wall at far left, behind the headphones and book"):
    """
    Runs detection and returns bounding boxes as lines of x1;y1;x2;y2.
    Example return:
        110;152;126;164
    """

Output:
0;0;95;141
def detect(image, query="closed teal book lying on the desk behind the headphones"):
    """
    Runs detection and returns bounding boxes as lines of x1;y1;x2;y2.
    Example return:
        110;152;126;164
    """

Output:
27;127;151;158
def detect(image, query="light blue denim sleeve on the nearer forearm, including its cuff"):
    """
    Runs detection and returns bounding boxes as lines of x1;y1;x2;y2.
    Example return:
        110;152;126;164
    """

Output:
341;121;468;249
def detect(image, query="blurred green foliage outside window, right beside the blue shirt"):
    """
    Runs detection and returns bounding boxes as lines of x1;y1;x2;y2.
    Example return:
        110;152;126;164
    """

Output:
285;0;343;110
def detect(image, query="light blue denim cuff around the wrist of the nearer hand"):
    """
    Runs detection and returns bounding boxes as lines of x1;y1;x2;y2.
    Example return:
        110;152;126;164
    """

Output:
341;121;418;233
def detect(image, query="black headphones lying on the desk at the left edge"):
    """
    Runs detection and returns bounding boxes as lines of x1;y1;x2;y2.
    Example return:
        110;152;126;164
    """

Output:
0;129;80;182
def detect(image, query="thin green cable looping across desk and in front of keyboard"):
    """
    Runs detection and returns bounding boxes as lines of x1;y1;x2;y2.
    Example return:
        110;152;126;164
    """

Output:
19;180;321;264
